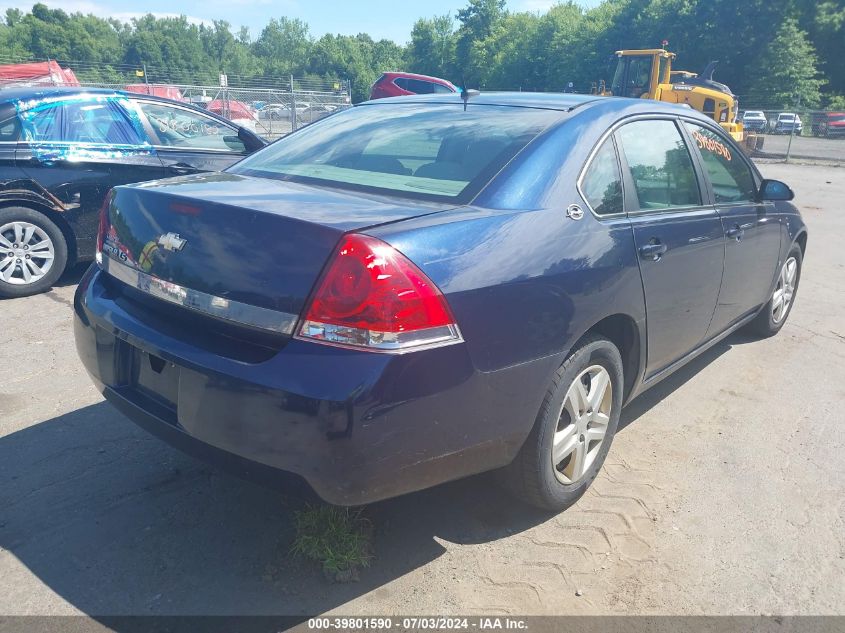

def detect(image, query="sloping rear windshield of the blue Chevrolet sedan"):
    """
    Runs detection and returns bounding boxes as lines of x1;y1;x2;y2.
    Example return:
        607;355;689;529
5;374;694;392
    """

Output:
229;101;563;202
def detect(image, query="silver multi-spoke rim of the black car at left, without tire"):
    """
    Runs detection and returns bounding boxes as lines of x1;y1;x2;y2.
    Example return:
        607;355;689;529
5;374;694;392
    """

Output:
0;222;56;286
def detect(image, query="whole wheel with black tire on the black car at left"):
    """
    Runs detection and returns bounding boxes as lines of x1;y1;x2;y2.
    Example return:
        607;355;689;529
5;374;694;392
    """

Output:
0;207;67;298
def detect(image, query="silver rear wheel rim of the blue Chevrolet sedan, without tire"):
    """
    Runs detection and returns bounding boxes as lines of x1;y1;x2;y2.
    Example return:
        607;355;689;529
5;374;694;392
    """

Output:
552;365;613;485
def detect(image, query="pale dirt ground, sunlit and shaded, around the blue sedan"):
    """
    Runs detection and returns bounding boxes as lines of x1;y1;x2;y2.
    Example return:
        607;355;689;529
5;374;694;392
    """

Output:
0;164;845;615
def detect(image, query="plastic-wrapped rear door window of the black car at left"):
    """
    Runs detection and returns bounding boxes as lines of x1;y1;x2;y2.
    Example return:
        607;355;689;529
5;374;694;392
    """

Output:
19;99;142;145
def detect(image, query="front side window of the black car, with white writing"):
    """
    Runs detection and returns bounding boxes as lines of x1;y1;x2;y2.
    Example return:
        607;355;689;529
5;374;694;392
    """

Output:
136;101;246;153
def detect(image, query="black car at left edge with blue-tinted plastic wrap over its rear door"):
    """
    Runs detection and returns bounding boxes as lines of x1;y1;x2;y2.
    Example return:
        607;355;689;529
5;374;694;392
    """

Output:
0;87;265;297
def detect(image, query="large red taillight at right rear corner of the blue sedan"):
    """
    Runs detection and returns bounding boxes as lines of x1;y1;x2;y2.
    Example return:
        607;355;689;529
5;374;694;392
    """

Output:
299;235;462;351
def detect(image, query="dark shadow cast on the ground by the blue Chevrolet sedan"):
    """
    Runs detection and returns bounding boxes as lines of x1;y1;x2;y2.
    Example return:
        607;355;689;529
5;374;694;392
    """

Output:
0;336;744;615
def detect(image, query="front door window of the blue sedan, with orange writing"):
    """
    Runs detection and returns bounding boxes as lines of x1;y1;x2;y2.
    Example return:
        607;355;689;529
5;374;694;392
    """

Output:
686;123;757;203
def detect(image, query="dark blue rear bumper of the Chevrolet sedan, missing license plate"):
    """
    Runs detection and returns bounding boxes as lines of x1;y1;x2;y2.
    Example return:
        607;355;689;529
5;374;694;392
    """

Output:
74;266;559;505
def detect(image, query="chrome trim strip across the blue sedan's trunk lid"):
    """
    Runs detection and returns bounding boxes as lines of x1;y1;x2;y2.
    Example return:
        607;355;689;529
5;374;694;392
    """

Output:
98;253;299;334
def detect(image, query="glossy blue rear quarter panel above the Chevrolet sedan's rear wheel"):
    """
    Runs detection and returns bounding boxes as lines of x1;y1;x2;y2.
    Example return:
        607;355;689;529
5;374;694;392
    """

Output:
368;106;645;410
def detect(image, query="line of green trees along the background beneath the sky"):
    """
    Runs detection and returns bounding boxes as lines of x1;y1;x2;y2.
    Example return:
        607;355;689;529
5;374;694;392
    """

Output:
0;0;845;109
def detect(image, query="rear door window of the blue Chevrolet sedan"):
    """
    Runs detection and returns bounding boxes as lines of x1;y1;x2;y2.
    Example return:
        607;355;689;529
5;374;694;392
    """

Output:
617;120;701;211
